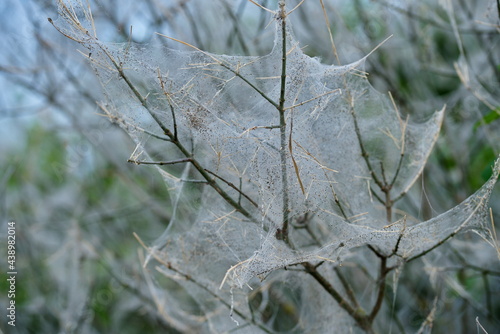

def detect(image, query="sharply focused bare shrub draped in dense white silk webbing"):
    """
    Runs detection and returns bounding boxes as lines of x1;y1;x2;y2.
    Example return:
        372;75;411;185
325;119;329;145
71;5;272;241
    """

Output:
17;2;500;333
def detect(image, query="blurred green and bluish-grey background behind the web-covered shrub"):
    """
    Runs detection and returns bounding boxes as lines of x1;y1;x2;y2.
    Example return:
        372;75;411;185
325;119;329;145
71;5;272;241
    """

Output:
0;0;500;333
